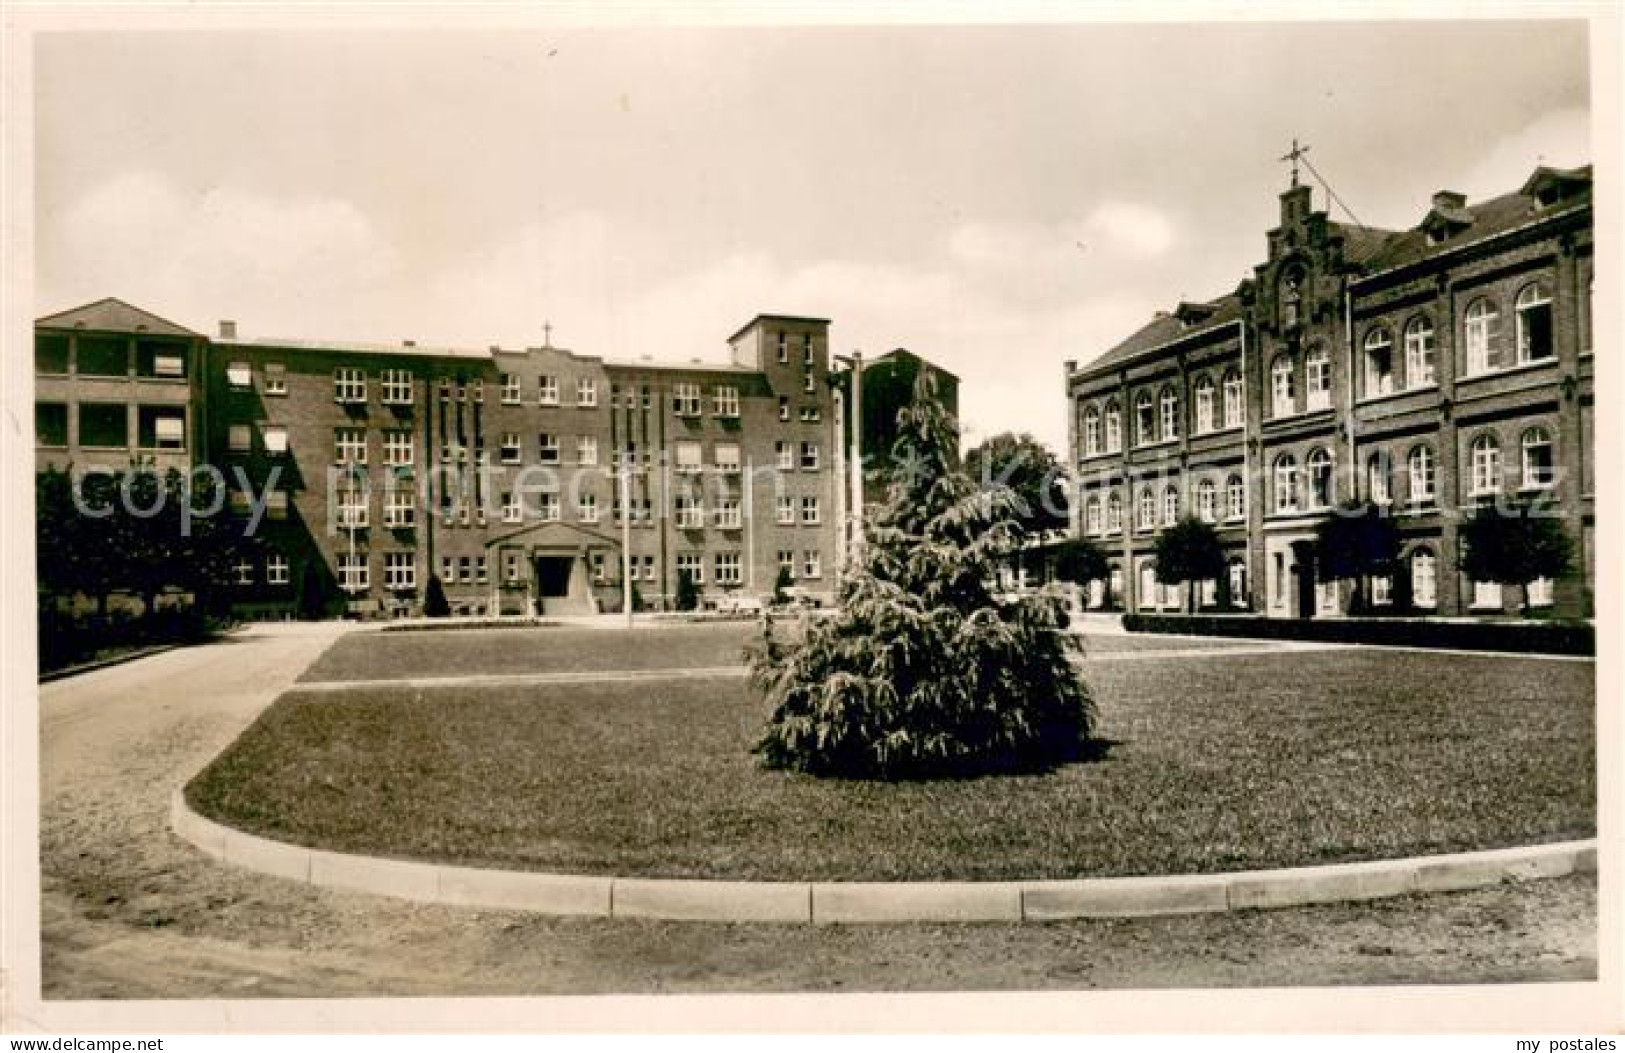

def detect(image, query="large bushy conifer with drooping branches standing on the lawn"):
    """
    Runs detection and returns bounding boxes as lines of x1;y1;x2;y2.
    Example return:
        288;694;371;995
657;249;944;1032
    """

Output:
749;374;1095;778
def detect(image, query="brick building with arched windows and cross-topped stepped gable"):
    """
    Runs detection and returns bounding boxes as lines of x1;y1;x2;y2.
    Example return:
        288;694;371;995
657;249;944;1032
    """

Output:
1066;166;1596;618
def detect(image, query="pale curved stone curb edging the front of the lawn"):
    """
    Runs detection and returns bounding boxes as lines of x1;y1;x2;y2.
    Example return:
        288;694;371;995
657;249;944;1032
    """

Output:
169;790;1597;925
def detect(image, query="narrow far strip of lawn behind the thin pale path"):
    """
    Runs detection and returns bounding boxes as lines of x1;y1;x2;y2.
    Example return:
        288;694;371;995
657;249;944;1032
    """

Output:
299;618;1250;683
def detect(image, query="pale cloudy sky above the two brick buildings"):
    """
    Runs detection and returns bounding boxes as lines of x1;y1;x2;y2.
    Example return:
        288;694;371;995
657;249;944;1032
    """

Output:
36;21;1591;447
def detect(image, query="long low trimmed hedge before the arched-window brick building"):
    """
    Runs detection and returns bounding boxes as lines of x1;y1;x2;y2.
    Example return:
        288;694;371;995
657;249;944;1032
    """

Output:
1123;614;1597;655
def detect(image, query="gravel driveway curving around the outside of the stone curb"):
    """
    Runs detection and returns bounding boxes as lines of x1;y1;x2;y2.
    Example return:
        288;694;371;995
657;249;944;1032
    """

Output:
41;626;1597;999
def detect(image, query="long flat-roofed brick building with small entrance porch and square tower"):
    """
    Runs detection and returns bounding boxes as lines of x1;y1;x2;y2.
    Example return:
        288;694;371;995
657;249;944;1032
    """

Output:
36;301;835;614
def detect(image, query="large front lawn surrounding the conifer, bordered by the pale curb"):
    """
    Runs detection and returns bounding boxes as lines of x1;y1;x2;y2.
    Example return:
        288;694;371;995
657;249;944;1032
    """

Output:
187;626;1596;881
